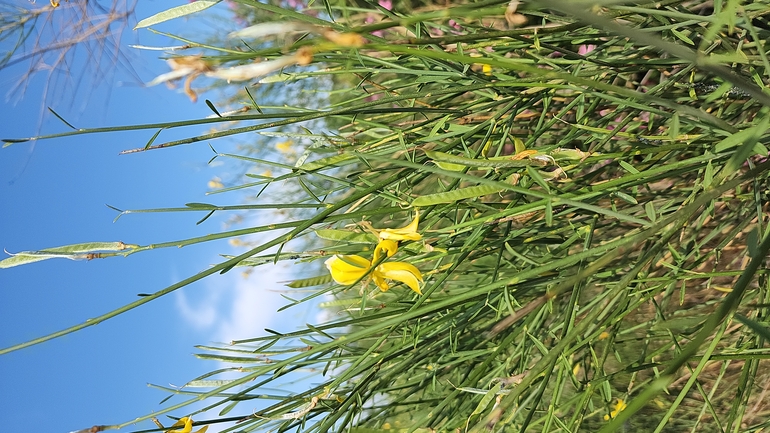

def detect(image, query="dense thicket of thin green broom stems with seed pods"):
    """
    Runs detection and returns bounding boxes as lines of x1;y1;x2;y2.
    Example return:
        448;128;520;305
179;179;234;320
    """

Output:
0;0;770;432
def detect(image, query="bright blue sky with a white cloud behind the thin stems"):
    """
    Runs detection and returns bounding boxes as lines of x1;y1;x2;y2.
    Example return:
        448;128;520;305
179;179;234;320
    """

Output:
0;1;315;432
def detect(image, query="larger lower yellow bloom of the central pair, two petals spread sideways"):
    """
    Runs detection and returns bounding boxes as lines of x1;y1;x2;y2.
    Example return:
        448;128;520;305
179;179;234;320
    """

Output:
326;246;423;295
